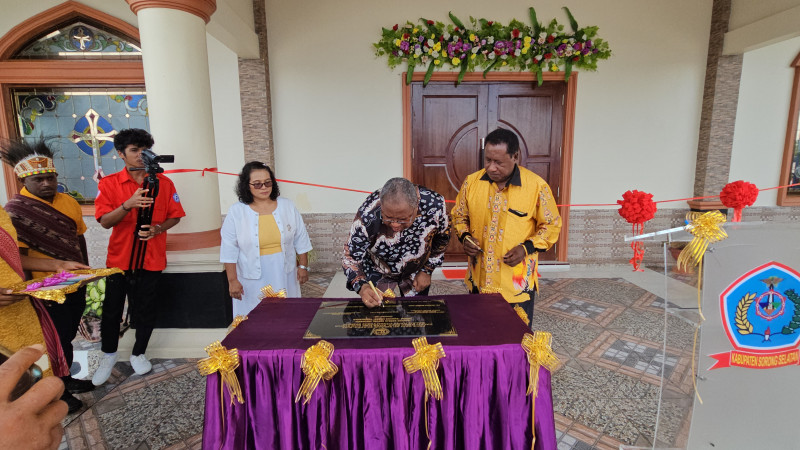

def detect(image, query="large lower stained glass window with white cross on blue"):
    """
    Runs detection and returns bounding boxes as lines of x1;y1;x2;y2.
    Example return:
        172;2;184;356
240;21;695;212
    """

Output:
13;88;150;203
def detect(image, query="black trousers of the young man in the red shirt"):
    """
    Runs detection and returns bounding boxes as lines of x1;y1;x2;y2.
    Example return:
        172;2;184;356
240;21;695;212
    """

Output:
100;270;161;355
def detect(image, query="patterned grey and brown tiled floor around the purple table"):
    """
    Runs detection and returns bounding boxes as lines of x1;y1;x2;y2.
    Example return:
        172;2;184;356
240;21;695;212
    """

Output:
60;267;697;450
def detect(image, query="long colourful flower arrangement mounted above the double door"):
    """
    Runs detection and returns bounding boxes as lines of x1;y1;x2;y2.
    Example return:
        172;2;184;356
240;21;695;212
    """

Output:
373;7;611;85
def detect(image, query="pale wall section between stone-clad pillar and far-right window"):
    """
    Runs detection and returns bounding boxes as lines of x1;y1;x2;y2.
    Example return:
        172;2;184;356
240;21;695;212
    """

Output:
730;37;800;206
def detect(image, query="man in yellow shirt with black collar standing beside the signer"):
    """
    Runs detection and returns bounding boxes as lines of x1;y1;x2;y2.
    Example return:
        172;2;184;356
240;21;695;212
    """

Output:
450;128;561;324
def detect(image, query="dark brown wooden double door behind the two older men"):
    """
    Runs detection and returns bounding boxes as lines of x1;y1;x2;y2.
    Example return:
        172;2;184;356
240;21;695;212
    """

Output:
411;81;566;261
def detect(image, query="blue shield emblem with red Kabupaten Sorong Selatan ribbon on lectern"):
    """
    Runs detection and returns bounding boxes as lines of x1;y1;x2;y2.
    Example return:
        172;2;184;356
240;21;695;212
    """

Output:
710;262;800;369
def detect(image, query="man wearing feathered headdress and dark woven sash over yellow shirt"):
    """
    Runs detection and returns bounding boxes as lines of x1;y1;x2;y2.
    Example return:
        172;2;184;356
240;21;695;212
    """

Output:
2;140;94;413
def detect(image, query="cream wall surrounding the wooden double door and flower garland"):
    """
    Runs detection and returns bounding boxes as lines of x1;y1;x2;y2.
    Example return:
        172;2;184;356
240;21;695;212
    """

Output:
267;0;711;212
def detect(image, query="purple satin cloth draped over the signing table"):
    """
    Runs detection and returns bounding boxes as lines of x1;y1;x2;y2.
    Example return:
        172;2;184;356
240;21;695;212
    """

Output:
203;294;556;450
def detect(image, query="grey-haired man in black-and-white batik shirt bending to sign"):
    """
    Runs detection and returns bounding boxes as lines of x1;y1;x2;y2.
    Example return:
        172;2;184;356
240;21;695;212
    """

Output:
342;178;450;307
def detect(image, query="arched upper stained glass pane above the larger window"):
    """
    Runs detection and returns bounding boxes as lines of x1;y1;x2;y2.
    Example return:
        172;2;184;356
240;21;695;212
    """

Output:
14;22;142;59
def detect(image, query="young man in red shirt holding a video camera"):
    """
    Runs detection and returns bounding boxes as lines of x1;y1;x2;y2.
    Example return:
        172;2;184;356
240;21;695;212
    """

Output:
92;128;186;386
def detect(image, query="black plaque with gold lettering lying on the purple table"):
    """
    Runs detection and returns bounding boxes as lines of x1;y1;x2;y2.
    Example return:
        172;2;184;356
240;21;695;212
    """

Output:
303;299;456;339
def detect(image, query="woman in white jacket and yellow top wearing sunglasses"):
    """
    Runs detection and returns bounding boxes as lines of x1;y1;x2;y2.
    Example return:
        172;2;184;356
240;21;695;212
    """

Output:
220;161;318;317
